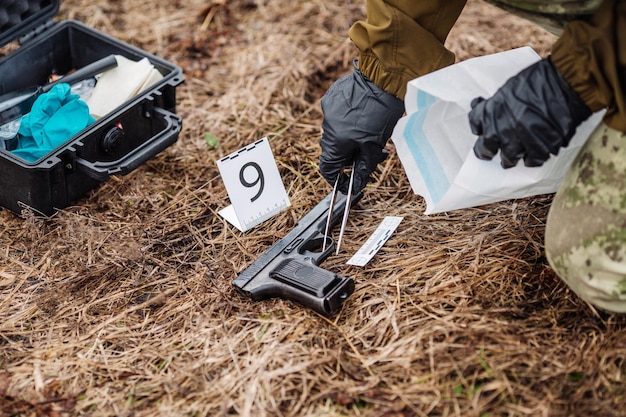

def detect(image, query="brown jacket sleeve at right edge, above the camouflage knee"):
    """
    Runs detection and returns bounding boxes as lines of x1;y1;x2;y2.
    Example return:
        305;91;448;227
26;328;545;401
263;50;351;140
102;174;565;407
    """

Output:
552;0;626;132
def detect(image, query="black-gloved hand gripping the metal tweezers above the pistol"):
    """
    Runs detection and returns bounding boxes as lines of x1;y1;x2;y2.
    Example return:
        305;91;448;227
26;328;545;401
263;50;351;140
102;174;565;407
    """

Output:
320;61;404;194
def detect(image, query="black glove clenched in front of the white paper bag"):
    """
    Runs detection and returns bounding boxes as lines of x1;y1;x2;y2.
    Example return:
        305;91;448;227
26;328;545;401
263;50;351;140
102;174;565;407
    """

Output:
469;58;591;168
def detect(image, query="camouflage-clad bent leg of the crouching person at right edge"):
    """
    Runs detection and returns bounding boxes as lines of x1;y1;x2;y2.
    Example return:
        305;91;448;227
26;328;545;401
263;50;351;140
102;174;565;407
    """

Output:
545;123;626;313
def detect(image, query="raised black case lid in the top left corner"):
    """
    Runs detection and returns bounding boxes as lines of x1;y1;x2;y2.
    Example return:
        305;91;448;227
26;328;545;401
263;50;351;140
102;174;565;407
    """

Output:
0;0;61;46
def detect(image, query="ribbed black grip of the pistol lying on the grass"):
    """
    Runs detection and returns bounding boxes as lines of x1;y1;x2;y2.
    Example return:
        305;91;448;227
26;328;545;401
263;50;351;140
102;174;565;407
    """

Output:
270;258;354;316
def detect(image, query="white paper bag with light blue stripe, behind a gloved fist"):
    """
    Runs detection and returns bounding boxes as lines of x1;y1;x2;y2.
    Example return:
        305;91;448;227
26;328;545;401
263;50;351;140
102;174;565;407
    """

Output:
392;47;602;214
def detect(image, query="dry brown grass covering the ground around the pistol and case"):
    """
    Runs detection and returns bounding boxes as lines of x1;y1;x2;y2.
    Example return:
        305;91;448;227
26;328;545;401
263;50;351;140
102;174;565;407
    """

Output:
0;0;626;417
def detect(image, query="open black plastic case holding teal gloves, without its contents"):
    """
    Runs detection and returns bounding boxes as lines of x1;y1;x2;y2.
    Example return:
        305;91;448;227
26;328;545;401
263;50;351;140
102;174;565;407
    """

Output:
0;0;184;215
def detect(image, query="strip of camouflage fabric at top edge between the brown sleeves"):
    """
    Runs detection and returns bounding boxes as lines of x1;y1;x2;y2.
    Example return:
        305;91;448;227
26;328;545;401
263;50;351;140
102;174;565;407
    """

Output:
486;0;602;35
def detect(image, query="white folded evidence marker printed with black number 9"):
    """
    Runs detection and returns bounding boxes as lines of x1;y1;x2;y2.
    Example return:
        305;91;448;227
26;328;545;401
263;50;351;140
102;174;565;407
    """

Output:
217;137;291;232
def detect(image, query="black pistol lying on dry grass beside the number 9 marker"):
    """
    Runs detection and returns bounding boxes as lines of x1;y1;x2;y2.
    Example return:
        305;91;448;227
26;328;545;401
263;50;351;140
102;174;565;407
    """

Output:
232;192;363;317
